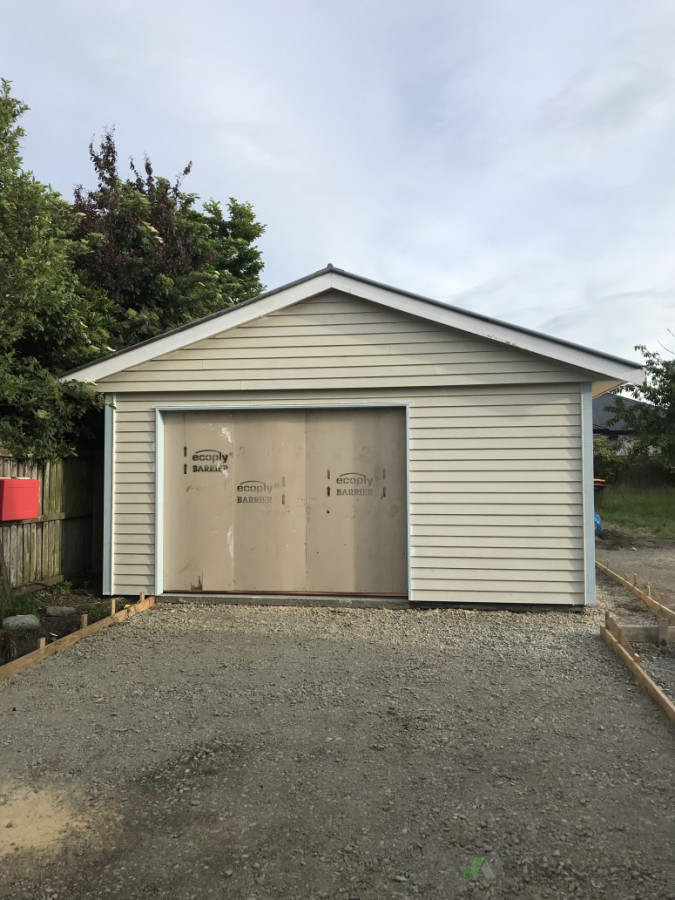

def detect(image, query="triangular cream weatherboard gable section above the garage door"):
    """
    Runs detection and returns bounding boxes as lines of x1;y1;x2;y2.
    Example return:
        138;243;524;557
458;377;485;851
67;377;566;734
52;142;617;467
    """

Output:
95;292;582;392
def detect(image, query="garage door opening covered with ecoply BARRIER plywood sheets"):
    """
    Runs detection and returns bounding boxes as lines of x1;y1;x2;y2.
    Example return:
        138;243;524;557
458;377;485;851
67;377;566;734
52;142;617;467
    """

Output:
163;407;408;597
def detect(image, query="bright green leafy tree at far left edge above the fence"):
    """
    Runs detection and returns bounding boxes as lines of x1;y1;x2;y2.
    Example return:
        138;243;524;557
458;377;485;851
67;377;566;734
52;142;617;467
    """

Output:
0;79;103;458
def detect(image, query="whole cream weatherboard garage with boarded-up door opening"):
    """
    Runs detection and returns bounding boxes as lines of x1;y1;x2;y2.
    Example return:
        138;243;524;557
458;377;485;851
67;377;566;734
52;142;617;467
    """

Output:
64;266;643;606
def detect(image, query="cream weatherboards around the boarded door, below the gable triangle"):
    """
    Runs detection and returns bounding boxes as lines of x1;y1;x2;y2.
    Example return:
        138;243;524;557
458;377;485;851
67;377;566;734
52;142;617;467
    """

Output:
113;382;584;604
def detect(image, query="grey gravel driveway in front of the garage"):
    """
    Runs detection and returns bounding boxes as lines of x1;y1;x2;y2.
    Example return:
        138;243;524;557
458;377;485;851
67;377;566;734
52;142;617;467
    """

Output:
0;582;675;900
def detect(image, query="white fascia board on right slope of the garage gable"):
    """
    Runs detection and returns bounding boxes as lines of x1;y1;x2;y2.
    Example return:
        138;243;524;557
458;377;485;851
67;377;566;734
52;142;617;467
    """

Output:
333;273;644;383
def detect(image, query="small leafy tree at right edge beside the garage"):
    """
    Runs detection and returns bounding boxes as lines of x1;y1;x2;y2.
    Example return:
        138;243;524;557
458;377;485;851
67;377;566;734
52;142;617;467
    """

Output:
607;345;675;468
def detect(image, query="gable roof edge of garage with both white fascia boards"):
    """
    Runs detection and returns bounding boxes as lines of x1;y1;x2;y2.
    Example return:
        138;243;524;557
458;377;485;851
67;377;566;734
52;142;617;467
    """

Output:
61;264;643;394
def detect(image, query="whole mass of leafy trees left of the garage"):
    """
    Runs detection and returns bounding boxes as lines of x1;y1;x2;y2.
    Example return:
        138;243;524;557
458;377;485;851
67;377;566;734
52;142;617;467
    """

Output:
0;80;264;459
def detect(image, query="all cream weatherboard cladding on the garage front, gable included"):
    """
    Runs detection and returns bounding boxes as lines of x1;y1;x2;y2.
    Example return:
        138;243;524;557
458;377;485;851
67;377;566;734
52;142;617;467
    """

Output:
100;294;588;603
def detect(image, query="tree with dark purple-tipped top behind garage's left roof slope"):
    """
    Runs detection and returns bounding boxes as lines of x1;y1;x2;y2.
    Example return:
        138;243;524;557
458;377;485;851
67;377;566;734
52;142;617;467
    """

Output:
74;131;264;349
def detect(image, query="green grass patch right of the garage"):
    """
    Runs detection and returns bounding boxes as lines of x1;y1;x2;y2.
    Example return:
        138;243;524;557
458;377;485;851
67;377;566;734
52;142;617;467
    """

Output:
595;486;675;540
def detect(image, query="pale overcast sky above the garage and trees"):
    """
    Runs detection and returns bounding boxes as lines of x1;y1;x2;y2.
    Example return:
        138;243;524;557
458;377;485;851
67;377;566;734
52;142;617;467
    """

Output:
0;0;675;359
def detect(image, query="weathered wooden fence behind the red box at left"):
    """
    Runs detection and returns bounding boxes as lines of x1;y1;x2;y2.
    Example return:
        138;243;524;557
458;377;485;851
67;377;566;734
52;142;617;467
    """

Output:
0;449;103;586
